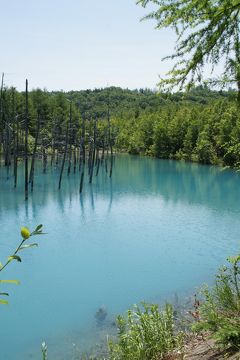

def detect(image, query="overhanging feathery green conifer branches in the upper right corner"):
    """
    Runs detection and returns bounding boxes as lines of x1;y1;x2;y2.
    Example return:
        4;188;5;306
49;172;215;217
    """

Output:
137;0;240;102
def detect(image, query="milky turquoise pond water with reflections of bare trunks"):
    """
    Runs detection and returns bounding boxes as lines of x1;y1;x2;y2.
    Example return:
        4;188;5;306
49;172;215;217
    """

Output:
0;155;240;360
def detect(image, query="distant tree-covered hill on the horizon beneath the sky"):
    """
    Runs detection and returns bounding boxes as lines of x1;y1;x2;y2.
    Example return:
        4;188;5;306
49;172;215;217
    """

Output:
48;86;236;118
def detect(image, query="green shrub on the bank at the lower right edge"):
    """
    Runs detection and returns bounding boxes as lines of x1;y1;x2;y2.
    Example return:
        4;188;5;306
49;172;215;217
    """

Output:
193;255;240;350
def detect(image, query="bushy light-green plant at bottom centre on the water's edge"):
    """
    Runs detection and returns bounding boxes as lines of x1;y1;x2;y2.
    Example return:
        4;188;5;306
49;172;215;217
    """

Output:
109;304;184;360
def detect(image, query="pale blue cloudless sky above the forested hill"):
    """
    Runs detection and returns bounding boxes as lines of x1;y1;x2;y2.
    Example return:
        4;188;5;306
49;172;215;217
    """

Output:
0;0;176;90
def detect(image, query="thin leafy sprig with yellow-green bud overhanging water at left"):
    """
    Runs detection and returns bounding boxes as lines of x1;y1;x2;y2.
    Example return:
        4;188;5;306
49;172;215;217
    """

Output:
0;224;43;304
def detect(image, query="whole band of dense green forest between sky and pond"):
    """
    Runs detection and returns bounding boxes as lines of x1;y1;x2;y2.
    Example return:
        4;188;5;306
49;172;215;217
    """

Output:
0;86;240;172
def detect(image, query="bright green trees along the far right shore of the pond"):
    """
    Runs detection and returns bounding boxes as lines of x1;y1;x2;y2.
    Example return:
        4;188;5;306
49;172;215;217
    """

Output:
114;96;240;168
